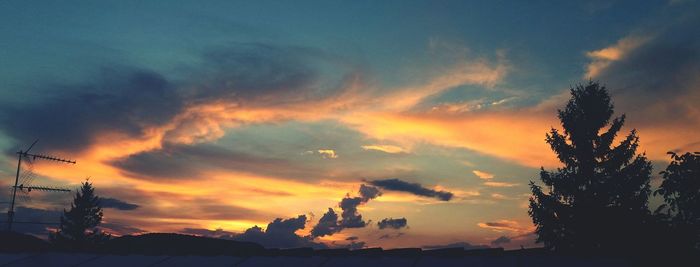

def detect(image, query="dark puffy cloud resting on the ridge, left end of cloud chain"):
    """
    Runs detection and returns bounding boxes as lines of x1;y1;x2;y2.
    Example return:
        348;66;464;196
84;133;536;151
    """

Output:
233;215;325;248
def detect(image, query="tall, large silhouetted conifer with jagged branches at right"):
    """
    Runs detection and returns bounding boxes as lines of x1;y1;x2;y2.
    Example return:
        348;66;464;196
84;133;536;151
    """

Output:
528;81;651;252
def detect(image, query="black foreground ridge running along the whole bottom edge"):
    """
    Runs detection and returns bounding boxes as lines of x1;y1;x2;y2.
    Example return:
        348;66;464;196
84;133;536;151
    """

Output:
0;232;700;267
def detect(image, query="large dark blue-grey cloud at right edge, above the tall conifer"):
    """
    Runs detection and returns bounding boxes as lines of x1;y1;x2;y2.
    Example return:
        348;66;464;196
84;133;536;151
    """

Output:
595;16;700;125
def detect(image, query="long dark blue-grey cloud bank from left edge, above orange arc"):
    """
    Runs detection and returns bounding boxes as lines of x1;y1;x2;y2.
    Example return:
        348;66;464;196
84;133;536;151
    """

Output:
0;44;342;155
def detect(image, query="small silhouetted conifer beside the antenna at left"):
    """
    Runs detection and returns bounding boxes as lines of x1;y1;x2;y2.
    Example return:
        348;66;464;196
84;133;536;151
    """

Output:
49;181;109;250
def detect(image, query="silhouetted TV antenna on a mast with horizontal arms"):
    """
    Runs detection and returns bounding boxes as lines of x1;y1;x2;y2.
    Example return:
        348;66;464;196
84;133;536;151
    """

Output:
7;139;76;231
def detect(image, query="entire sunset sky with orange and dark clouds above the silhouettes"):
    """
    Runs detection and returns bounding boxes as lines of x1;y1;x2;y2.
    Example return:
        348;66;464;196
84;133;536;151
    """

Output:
0;0;700;248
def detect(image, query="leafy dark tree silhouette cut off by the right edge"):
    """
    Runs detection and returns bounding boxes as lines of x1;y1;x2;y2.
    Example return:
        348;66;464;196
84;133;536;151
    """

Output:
654;152;700;249
